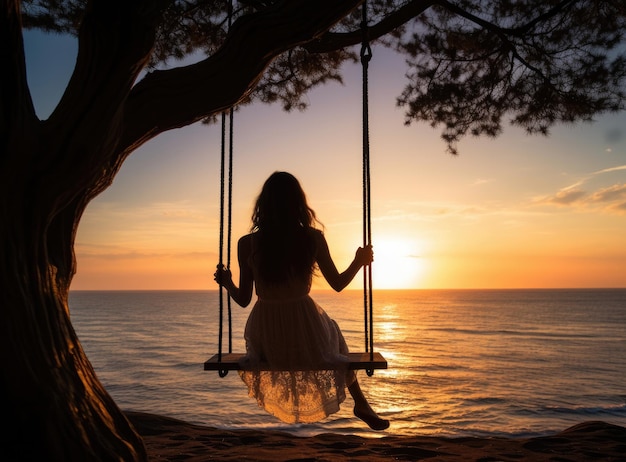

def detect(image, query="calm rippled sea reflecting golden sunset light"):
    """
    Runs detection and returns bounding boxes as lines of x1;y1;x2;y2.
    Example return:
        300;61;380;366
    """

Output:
70;289;626;437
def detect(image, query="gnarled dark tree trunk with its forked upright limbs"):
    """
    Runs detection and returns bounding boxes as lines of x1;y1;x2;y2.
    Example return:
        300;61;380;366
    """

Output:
0;0;151;461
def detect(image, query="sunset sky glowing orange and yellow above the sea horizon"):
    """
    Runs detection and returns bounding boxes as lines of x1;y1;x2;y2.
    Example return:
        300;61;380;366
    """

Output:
25;28;626;290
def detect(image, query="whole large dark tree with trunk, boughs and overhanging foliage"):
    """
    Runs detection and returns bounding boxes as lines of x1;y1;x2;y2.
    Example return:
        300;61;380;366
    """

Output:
0;0;626;461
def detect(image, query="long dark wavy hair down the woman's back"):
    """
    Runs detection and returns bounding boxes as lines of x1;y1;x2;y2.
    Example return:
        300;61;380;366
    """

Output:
252;172;317;285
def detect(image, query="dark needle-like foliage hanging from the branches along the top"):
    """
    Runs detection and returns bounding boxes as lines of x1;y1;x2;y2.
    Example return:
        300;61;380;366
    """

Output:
23;0;626;153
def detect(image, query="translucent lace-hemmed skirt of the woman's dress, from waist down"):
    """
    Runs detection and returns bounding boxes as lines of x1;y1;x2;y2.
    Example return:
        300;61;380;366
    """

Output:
239;276;354;424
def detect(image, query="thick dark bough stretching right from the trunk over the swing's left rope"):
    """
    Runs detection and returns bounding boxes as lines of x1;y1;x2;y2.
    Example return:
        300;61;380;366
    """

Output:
120;0;362;155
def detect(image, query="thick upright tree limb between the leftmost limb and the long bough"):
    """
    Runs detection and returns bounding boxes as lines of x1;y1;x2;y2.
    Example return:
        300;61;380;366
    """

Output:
33;0;165;197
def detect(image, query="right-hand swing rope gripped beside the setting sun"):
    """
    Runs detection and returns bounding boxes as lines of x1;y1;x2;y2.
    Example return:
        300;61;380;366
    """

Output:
361;0;374;376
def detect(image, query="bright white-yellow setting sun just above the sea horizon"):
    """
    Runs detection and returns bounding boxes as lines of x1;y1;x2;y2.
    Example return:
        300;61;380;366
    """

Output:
372;237;428;289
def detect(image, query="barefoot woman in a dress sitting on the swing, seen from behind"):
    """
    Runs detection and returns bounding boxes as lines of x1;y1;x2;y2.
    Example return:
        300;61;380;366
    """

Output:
215;172;389;430
